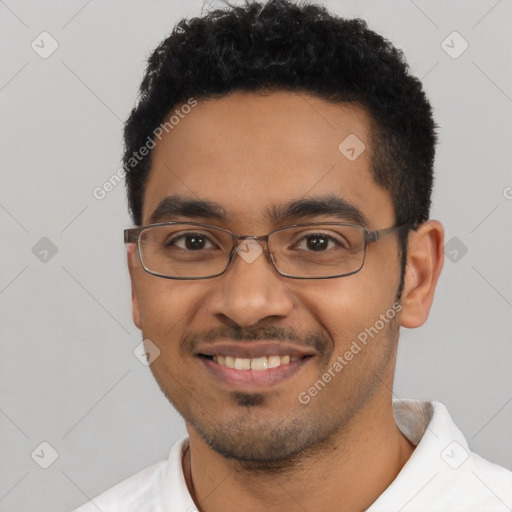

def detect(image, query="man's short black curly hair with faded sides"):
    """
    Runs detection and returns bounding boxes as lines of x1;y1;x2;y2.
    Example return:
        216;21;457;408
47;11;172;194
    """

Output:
123;0;436;235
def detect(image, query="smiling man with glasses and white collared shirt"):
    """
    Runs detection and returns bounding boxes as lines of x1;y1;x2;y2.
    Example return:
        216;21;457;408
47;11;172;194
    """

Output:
74;0;512;512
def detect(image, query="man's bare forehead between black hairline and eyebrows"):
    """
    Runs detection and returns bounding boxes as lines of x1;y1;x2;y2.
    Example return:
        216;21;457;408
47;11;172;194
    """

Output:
143;92;393;228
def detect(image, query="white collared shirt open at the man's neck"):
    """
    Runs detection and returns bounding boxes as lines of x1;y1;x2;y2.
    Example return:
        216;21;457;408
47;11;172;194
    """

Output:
76;400;512;512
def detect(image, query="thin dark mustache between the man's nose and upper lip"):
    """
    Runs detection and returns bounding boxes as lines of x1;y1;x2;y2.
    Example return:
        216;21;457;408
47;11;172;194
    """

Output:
180;325;329;354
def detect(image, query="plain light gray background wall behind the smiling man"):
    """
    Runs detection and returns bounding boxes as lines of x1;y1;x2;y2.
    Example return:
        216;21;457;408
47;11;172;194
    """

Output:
0;0;512;512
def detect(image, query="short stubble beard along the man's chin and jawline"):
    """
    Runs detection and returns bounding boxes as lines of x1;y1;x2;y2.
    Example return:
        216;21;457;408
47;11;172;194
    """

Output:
156;318;399;474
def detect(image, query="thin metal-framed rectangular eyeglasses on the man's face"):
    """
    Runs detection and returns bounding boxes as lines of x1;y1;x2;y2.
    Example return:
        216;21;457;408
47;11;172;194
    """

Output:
124;222;409;279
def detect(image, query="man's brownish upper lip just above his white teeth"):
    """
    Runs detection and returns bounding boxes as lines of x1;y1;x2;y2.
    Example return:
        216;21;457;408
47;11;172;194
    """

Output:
196;341;315;359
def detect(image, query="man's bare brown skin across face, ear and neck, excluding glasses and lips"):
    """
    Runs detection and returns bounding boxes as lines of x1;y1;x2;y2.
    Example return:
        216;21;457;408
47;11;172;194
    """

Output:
128;92;443;512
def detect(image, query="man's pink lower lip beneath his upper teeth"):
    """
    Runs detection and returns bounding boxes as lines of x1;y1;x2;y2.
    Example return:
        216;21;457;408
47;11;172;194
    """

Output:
199;357;312;390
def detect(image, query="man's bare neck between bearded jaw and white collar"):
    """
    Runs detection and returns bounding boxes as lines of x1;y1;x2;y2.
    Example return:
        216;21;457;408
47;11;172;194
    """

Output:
183;402;414;512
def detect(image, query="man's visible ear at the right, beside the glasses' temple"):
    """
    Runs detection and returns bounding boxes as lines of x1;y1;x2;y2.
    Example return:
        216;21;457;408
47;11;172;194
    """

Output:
400;220;444;328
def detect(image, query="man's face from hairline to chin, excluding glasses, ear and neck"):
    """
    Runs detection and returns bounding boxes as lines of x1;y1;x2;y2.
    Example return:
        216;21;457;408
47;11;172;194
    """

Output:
129;92;406;461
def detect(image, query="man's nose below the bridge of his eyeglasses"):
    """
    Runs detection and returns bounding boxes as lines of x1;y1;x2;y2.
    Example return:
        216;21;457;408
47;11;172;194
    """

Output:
207;240;295;327
